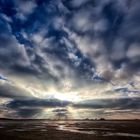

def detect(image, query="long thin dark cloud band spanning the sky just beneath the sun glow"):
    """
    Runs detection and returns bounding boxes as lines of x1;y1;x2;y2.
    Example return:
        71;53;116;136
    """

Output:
7;97;140;112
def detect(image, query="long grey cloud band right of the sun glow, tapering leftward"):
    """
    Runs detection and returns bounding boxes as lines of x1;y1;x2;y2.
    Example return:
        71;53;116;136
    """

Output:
74;98;140;110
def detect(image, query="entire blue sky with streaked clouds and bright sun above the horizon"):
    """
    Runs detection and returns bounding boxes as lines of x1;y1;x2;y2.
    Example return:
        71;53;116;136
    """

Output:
0;0;140;119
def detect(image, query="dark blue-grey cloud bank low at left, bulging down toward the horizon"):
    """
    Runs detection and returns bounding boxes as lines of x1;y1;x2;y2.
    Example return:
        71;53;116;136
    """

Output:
4;98;71;118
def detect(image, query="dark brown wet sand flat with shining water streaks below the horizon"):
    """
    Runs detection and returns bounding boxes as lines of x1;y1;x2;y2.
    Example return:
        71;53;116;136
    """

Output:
0;120;140;140
